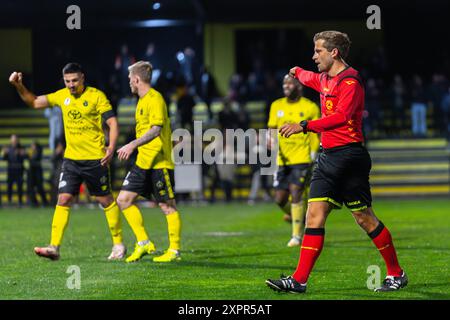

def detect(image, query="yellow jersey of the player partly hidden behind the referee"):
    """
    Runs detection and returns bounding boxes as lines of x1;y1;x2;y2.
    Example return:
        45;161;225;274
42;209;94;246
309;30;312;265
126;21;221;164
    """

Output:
267;97;320;166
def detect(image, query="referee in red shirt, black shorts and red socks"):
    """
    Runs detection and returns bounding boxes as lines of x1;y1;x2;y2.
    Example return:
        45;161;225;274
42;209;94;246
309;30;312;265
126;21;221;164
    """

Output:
266;31;408;293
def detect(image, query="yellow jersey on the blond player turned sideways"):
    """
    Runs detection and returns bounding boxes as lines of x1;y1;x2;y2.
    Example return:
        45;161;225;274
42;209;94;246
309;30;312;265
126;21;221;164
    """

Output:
136;88;175;169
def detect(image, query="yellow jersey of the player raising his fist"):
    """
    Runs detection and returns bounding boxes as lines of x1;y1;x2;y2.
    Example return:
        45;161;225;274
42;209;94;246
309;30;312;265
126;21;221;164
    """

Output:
47;87;112;160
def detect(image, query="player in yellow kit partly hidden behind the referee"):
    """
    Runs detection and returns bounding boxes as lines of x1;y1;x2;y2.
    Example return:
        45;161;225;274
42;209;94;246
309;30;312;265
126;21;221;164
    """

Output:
267;75;320;247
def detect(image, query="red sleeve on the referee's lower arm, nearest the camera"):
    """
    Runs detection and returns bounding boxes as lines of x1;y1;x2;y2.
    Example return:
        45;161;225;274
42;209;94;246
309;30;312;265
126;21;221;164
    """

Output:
307;81;363;132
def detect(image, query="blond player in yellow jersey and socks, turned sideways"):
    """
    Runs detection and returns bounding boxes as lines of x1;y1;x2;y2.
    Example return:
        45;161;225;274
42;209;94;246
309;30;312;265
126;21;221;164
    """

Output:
117;61;181;262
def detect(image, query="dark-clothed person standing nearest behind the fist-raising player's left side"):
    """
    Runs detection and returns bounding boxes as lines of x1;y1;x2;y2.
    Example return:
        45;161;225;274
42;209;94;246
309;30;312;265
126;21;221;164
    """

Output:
27;141;48;207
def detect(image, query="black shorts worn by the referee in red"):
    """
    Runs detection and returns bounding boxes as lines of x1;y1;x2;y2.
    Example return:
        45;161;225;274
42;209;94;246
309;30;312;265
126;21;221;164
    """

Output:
308;143;372;211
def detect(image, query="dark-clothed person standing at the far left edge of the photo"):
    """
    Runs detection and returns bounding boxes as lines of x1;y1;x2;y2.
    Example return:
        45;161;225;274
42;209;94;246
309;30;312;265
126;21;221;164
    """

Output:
3;134;27;206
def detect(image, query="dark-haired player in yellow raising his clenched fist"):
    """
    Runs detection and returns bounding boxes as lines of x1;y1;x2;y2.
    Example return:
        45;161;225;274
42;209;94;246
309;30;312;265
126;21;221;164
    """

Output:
9;63;126;260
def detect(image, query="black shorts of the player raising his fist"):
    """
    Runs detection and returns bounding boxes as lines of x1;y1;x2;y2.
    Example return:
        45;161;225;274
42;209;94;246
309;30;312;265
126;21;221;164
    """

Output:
58;158;111;196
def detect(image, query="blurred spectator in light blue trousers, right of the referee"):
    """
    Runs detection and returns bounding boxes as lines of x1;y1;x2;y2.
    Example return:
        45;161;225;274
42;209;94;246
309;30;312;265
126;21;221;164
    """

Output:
411;75;427;137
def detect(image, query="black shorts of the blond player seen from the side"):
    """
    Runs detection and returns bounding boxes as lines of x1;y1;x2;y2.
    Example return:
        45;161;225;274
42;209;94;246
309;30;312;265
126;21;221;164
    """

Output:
121;165;175;202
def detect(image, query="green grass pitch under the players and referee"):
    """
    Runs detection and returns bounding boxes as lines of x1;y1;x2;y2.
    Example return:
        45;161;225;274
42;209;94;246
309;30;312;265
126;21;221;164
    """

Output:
0;199;450;300
